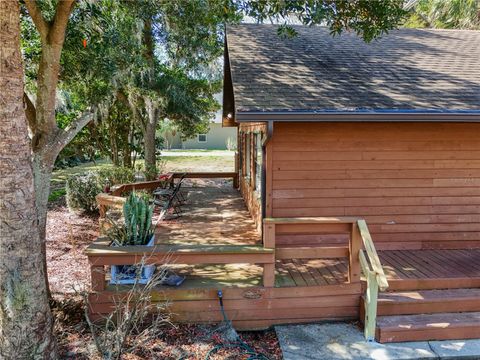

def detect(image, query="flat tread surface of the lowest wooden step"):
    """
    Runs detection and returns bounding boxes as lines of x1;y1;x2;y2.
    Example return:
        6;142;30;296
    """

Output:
377;312;480;331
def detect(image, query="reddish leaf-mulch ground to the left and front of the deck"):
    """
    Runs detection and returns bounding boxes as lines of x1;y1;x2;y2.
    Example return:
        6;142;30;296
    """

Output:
47;198;282;360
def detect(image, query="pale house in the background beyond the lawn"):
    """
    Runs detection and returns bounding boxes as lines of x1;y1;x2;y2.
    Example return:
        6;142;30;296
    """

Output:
158;94;237;150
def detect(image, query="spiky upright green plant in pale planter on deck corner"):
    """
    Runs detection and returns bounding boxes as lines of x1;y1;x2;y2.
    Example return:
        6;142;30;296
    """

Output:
107;192;155;284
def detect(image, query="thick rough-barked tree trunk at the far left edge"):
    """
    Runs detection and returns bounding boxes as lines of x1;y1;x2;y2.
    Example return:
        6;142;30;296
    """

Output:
0;1;57;359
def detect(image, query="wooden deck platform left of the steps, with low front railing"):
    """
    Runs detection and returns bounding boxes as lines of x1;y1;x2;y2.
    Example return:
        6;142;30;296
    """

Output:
88;183;361;329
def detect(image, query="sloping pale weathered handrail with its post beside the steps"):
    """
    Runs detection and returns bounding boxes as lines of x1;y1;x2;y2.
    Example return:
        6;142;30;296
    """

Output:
357;220;388;341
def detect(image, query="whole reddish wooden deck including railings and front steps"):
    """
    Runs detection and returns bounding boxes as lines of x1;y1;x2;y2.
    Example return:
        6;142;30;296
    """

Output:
88;183;480;341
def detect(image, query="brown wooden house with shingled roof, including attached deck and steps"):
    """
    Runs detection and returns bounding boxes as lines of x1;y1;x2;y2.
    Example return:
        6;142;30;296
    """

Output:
87;24;480;342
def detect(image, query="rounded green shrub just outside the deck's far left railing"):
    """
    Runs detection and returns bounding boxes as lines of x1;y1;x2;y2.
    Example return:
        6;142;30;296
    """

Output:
65;167;135;213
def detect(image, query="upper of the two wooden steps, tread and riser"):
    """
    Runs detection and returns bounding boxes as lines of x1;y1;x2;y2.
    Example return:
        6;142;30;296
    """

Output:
377;289;480;316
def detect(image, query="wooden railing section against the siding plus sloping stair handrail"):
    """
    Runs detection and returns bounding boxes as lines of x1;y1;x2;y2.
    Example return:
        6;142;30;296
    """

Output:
263;217;388;341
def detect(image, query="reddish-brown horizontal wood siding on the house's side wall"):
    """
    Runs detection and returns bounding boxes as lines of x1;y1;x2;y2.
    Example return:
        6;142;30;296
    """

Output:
267;122;480;249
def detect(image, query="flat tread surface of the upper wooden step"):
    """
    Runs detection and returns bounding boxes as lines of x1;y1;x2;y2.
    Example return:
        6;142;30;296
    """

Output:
378;289;480;305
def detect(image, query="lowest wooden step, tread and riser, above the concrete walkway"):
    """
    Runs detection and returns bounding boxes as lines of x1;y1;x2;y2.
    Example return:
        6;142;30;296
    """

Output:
376;312;480;343
